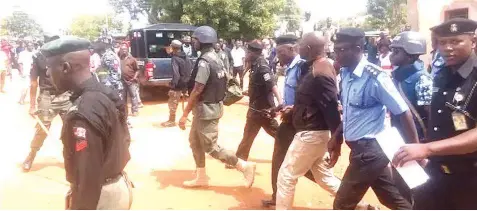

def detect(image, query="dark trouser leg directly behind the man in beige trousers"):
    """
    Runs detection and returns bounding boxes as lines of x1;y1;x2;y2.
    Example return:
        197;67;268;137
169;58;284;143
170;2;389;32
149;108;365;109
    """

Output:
272;122;315;201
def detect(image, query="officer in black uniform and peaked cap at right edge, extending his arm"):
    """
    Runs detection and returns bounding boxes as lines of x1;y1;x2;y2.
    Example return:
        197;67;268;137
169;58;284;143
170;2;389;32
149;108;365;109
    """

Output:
393;18;477;210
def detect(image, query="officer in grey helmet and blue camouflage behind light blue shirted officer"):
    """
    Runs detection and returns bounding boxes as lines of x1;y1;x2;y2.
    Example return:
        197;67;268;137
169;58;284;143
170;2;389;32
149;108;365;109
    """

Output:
390;31;432;202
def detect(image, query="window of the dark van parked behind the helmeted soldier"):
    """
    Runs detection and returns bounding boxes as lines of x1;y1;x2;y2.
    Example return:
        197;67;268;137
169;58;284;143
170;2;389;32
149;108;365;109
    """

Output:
146;30;191;58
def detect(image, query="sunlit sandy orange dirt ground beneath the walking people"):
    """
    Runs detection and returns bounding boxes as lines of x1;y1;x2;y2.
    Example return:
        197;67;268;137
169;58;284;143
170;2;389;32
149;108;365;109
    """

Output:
0;76;382;210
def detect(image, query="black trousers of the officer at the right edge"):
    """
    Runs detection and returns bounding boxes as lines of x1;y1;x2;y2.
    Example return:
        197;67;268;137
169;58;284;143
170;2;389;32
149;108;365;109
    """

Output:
413;161;477;210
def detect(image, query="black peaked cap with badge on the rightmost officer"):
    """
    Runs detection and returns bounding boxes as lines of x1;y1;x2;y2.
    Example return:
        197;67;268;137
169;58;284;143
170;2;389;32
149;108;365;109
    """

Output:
431;18;477;37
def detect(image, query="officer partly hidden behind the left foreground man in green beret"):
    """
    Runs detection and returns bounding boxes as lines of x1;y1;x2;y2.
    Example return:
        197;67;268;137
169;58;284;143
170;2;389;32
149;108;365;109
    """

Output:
22;35;71;171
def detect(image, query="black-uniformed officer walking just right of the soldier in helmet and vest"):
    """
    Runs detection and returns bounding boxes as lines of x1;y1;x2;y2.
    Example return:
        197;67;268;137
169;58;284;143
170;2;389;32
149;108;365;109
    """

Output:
232;40;282;163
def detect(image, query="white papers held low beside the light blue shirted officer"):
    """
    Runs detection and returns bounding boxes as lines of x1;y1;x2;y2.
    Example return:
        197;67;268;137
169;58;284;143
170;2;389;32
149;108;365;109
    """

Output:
376;127;429;189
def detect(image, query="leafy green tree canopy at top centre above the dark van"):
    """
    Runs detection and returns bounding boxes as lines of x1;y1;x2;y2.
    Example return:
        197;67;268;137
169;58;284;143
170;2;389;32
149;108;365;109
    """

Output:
109;0;285;39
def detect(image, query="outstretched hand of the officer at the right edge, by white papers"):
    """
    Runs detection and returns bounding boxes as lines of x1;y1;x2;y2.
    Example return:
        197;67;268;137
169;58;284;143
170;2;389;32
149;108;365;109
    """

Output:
393;144;431;167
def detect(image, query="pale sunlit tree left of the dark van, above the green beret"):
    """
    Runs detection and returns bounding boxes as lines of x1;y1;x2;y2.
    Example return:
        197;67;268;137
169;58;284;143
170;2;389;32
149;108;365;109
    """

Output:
69;15;122;40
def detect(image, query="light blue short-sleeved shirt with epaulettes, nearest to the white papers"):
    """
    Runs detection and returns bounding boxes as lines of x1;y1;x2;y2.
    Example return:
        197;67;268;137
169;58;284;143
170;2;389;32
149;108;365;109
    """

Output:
341;57;409;141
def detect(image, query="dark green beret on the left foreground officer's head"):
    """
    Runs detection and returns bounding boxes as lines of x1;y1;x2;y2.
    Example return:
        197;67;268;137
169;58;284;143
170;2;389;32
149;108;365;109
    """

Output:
40;36;91;57
